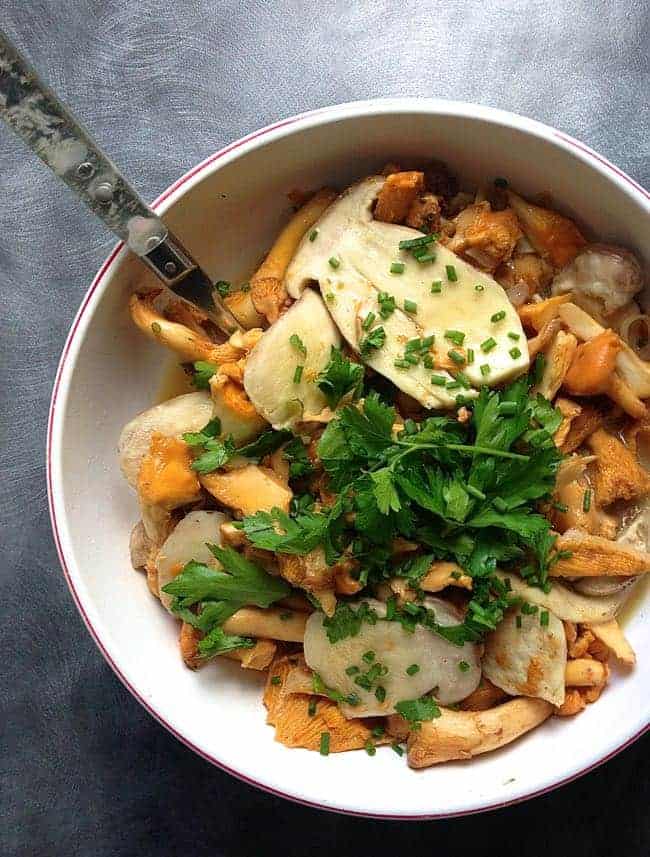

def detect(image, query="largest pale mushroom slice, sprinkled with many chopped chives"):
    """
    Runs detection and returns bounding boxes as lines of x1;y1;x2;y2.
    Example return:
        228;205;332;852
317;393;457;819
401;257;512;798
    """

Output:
285;176;529;408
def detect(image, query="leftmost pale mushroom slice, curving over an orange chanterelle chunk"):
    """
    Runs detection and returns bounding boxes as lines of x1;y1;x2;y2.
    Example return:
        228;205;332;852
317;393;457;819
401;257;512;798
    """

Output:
118;392;259;488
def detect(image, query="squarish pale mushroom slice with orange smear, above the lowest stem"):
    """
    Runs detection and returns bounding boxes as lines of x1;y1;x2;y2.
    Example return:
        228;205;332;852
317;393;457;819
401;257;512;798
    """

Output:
483;608;567;705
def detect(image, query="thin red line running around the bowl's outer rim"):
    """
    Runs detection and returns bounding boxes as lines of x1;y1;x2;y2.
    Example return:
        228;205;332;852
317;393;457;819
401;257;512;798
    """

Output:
46;99;650;821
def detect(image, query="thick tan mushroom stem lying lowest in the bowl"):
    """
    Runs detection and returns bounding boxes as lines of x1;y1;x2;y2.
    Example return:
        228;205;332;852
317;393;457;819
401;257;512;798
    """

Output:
408;697;553;768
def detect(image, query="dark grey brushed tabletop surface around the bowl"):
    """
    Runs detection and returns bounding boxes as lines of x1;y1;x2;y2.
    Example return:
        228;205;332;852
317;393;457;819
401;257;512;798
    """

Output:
0;0;650;857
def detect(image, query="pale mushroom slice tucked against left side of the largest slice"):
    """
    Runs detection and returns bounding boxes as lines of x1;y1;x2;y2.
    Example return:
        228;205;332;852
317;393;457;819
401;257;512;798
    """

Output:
244;289;341;428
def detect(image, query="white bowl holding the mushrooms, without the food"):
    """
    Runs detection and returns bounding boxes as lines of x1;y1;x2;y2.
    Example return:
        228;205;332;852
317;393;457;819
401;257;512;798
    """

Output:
48;99;650;819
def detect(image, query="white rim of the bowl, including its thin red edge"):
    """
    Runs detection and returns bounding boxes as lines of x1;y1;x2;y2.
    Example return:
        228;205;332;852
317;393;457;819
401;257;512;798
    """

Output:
46;98;650;821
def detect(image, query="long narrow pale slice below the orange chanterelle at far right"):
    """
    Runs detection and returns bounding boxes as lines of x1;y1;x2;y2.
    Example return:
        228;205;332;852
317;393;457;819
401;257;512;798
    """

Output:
496;571;626;622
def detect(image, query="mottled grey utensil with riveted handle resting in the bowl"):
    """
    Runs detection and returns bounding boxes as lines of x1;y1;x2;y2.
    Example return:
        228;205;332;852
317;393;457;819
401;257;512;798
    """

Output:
0;30;239;333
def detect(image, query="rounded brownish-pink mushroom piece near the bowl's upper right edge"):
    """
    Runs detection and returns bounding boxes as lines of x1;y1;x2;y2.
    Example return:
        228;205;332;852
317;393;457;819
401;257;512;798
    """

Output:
552;244;643;317
